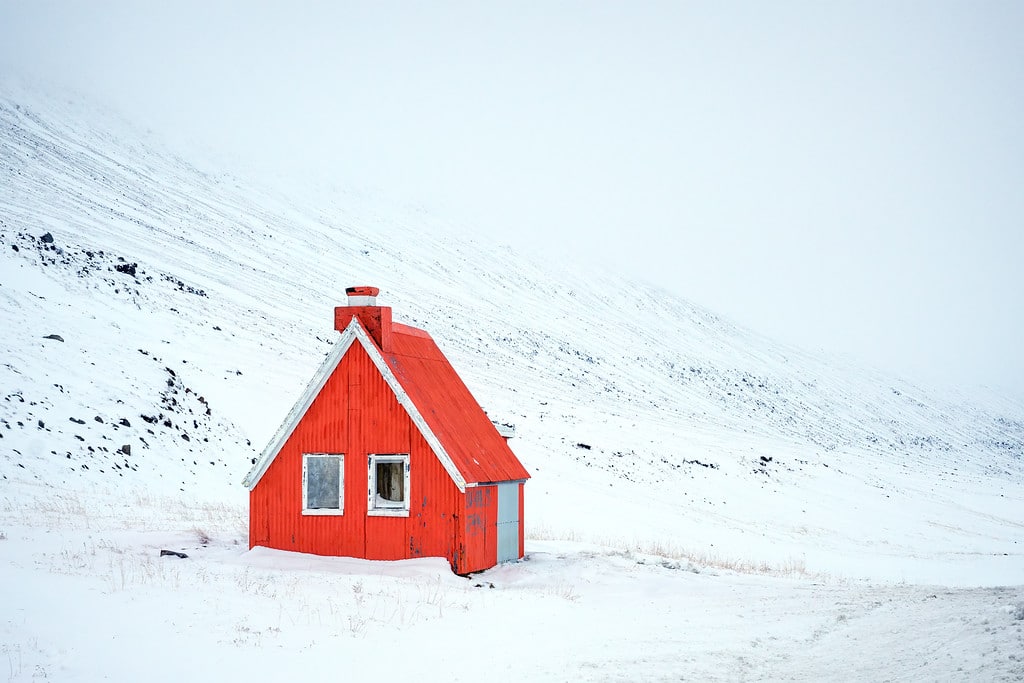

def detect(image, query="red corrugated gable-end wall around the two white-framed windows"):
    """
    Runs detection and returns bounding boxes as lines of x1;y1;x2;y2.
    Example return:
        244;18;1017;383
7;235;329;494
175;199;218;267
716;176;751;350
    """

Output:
249;344;468;573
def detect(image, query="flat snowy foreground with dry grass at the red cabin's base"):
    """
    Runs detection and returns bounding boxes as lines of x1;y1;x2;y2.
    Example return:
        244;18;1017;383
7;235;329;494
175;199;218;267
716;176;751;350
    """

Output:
0;516;1024;681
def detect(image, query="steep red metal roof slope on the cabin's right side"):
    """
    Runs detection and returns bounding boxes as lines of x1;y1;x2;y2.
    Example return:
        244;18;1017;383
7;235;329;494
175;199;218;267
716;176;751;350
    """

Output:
382;323;529;483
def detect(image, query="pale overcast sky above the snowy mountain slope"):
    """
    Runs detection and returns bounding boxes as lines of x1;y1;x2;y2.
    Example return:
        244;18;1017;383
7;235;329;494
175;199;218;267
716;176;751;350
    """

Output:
6;0;1024;397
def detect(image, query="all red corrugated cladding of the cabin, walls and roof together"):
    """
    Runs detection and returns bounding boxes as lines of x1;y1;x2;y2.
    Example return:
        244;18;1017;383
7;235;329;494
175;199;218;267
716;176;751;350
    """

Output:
249;313;529;573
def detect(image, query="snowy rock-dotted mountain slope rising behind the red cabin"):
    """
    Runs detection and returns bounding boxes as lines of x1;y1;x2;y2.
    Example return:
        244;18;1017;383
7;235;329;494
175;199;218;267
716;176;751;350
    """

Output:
0;81;1024;583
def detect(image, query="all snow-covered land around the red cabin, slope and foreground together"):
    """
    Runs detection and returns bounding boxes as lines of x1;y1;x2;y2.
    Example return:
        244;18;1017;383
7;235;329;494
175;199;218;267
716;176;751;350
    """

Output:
0;84;1024;680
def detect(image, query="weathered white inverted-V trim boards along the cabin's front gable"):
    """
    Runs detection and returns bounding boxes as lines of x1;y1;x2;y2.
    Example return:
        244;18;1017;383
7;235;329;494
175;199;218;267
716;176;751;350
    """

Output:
242;316;466;493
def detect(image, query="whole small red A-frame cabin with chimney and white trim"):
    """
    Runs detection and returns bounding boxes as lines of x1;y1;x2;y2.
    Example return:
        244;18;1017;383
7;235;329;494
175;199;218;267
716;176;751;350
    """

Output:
239;287;529;574
